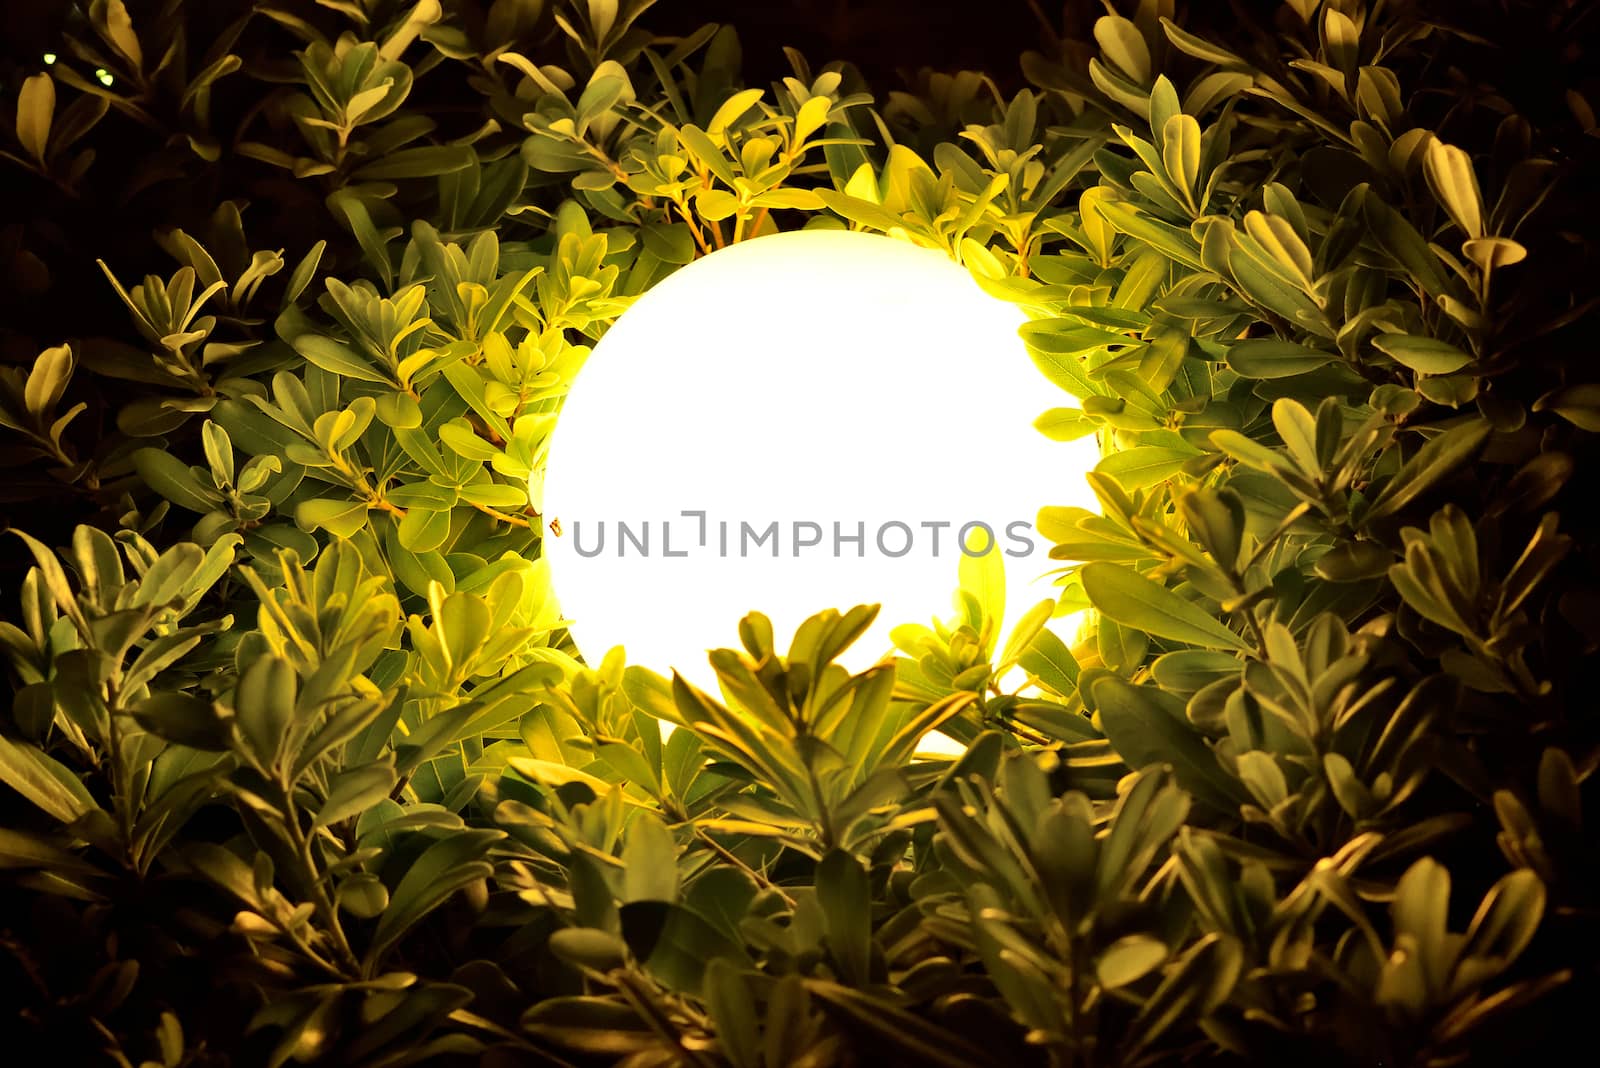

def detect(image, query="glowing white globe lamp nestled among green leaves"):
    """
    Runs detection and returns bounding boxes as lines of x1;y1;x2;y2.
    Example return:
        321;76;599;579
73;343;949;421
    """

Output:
542;230;1099;709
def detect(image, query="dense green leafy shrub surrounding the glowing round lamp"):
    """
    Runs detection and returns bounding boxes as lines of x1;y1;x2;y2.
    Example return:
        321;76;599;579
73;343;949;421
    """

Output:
0;0;1600;1068
